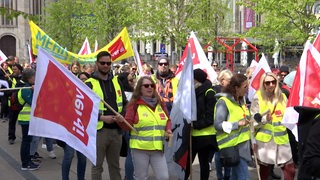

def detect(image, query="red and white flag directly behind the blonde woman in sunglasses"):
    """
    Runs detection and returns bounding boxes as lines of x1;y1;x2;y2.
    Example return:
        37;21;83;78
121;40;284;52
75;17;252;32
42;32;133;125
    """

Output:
248;54;271;101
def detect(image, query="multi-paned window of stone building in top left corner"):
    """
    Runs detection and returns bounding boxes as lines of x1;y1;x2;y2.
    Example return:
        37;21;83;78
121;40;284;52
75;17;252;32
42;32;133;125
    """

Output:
0;0;17;27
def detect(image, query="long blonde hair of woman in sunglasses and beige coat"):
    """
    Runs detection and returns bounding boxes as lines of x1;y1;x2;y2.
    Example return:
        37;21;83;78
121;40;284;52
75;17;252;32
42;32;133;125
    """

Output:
259;72;285;103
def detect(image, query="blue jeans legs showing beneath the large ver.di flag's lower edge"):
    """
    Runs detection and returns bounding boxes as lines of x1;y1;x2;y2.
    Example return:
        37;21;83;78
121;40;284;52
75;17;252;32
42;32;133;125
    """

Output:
61;144;87;180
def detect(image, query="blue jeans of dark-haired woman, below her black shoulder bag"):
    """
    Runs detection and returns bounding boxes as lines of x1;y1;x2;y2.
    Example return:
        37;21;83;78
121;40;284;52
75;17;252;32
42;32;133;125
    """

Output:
230;157;250;180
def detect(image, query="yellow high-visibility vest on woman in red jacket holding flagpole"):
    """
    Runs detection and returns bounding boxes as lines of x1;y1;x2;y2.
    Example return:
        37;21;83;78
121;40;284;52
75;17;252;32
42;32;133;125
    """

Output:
129;104;169;150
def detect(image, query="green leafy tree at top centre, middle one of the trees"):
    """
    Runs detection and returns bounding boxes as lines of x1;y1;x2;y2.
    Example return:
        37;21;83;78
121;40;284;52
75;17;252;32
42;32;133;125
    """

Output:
134;0;227;54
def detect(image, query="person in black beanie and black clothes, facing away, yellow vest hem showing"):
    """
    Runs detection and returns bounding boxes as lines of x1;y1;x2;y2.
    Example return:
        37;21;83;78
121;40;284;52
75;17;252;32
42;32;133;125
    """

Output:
185;69;218;180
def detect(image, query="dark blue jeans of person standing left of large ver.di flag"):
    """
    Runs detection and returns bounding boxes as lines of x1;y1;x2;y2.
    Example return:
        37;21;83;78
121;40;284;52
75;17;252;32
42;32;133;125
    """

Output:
20;124;32;167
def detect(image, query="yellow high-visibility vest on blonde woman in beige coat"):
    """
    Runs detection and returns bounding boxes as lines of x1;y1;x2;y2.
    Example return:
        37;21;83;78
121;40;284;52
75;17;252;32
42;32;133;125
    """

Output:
255;91;289;145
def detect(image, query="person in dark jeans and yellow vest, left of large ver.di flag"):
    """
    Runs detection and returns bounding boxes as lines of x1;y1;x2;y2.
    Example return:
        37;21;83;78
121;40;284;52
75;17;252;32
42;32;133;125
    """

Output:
18;69;40;171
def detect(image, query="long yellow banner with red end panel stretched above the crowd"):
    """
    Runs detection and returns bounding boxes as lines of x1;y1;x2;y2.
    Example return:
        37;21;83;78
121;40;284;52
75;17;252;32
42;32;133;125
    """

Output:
29;21;134;64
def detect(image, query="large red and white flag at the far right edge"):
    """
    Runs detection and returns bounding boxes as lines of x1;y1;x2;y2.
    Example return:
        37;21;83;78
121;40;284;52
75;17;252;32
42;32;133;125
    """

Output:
282;36;320;140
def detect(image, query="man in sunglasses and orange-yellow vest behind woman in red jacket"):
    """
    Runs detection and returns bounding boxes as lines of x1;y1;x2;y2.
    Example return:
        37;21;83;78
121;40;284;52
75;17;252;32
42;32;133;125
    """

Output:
156;56;178;114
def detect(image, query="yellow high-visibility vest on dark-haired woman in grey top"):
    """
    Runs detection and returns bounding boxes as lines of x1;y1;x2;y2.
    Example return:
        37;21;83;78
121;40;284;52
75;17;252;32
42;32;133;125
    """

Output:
215;97;250;149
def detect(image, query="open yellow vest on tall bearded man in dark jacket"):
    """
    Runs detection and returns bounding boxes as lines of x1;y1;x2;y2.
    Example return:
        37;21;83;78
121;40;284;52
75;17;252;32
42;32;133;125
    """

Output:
85;76;123;130
